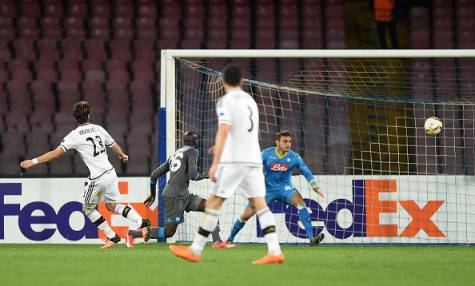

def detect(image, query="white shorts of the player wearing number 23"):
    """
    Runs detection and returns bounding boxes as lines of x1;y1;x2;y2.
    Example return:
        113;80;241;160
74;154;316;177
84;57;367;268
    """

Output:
82;169;120;207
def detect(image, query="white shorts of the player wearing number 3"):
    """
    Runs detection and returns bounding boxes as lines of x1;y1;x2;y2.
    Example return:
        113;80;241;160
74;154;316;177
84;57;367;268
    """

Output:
212;165;266;199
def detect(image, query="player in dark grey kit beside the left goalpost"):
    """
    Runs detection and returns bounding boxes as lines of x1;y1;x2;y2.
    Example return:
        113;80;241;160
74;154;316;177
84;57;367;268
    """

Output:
126;131;235;248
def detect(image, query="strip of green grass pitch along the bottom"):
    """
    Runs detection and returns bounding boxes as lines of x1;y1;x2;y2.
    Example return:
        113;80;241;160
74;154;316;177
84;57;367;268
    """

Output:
0;243;475;286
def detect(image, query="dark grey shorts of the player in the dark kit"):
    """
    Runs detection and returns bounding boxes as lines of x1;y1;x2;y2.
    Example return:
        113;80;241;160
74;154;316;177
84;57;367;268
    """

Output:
162;194;204;224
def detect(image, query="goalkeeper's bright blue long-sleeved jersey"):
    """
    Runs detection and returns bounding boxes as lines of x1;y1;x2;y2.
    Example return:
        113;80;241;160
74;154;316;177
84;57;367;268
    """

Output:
262;147;313;192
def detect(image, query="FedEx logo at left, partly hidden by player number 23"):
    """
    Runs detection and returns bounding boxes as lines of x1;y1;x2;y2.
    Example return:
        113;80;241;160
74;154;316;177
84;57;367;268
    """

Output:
0;182;158;241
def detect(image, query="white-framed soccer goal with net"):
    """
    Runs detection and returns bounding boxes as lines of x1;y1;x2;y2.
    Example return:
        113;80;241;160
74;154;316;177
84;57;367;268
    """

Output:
159;50;475;244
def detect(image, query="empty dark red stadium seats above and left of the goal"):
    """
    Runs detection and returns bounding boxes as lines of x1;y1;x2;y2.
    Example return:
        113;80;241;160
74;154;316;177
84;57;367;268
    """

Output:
0;0;475;177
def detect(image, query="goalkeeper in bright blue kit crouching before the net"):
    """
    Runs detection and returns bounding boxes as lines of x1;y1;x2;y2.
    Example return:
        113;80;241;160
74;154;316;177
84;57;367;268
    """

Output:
228;130;324;246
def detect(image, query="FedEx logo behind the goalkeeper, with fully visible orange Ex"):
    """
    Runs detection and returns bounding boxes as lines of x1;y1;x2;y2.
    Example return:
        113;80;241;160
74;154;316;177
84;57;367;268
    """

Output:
257;180;445;239
